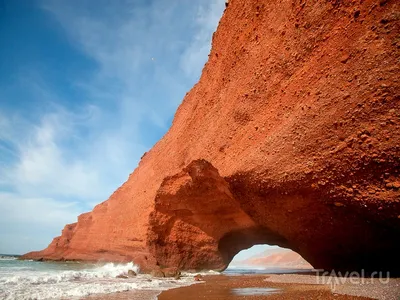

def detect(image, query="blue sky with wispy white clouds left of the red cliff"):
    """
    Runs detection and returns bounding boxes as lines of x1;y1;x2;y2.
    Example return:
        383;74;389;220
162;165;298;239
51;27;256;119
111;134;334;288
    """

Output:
0;0;270;254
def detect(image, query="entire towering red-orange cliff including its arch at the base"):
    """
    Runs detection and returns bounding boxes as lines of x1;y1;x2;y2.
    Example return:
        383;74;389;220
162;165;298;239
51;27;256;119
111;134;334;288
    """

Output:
25;0;400;272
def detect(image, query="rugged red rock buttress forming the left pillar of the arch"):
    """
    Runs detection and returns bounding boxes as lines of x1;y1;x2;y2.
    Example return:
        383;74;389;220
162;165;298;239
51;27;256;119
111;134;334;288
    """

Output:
148;160;278;269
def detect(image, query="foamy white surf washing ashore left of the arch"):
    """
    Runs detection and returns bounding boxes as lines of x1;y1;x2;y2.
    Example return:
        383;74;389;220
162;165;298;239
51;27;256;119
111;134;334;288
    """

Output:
0;263;194;300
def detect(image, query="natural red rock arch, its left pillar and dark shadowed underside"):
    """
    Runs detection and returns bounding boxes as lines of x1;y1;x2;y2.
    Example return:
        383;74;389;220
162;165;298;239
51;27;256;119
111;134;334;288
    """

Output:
147;160;398;270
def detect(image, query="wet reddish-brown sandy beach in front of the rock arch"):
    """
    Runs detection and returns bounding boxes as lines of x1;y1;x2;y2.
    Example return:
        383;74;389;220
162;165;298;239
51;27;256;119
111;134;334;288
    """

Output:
86;274;400;300
